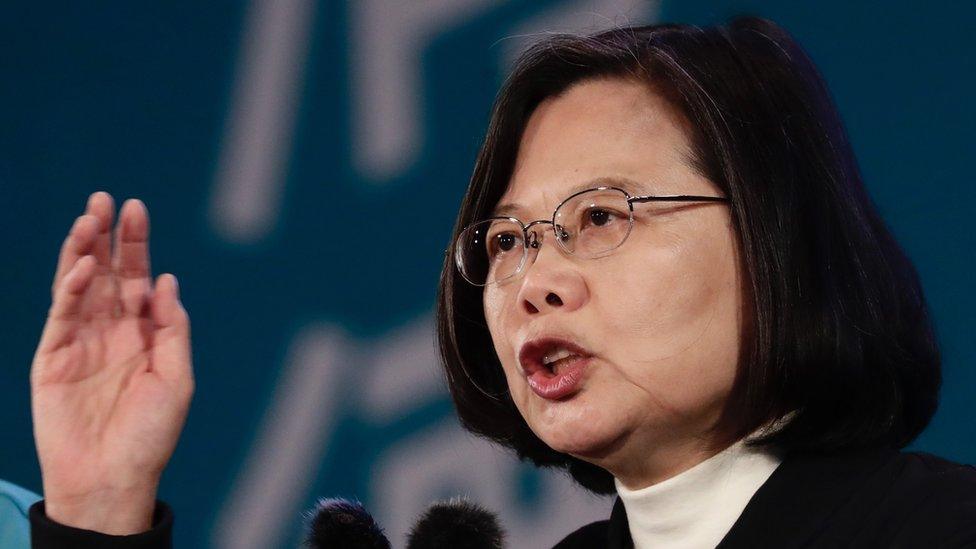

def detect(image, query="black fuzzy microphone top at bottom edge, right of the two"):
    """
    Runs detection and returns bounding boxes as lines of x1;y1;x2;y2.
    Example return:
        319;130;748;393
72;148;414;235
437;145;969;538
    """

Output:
407;498;505;549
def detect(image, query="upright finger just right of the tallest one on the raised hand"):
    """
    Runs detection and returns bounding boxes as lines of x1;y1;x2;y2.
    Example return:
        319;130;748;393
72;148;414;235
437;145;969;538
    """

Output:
112;199;152;316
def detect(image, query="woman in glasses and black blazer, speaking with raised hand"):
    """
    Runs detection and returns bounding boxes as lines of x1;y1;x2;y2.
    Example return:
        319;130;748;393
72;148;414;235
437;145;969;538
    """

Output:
24;18;976;547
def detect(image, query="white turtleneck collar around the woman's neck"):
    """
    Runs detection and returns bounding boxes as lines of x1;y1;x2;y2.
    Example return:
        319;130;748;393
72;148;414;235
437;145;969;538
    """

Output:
614;439;782;549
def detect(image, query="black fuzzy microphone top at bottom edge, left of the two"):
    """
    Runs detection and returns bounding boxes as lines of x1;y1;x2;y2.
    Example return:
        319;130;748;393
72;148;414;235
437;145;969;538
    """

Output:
305;498;390;549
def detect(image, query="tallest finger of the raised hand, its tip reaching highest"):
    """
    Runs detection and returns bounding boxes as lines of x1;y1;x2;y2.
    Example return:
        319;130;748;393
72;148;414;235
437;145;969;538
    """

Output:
86;191;120;317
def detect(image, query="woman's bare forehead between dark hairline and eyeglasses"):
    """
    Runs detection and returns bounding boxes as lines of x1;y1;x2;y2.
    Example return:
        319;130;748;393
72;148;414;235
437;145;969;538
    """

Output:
495;79;691;217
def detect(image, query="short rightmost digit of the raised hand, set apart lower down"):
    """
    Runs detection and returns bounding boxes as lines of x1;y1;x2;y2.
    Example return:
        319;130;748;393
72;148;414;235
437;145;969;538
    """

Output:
151;274;193;387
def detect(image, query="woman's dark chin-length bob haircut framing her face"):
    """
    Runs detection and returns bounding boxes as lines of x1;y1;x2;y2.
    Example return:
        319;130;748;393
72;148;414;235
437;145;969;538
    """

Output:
437;17;941;493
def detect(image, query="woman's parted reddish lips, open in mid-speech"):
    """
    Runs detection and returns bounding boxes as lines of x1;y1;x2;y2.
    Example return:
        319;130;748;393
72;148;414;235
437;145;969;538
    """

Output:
519;338;593;400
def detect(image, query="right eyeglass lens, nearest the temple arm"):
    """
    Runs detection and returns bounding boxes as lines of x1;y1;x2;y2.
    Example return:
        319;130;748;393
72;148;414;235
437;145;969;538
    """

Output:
554;189;633;257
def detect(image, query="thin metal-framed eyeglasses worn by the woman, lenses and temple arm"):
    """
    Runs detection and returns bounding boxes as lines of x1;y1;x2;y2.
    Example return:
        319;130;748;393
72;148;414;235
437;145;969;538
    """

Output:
454;187;731;286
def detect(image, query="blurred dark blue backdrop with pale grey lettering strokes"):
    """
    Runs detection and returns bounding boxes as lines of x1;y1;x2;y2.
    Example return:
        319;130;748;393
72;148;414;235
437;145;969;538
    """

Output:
0;0;976;548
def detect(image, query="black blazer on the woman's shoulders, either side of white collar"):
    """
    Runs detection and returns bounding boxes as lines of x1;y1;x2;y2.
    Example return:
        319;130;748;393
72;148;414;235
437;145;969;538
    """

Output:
556;450;976;549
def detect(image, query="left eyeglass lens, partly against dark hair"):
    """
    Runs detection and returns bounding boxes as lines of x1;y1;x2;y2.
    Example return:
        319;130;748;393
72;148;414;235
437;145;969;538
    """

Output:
454;219;525;286
